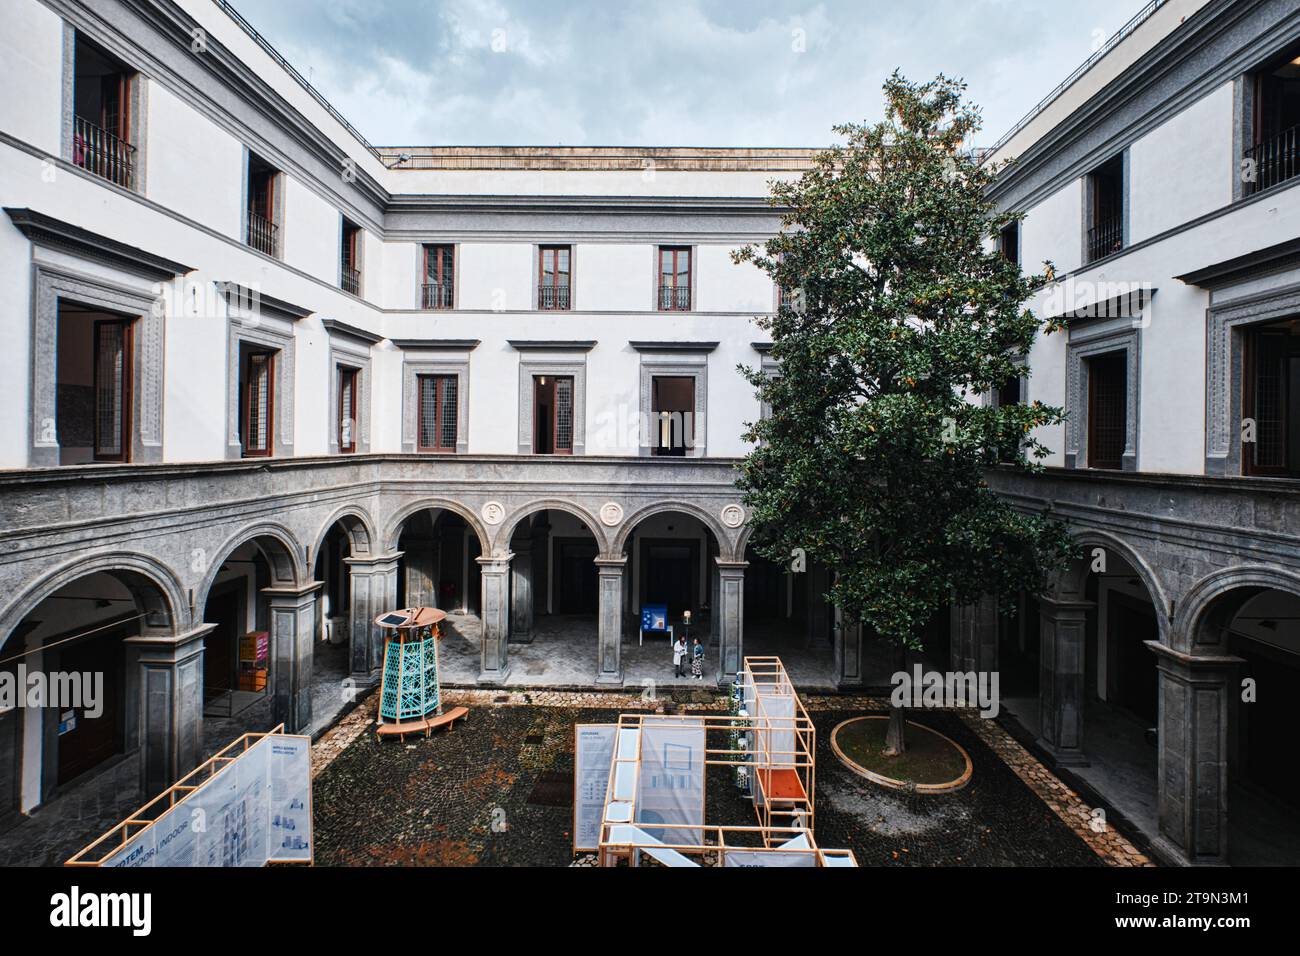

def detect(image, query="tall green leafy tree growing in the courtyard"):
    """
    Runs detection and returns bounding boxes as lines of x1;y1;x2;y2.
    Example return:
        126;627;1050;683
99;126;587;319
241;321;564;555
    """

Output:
736;73;1070;754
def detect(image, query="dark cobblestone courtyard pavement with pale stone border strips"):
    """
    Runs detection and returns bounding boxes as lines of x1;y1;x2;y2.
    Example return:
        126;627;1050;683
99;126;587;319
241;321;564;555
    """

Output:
306;688;1147;866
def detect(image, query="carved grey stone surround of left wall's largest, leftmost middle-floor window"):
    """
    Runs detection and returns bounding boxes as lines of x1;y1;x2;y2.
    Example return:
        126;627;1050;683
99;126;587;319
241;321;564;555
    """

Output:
27;263;165;468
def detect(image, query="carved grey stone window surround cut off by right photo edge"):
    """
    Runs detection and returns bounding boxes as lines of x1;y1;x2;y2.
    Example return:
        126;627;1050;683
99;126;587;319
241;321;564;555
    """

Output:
1205;284;1300;476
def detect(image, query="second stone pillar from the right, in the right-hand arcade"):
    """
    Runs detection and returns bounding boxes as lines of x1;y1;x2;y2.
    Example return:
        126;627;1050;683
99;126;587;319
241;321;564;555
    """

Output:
1039;596;1092;766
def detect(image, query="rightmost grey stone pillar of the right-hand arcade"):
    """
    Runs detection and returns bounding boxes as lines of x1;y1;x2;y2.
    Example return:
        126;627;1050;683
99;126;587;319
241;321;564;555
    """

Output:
1147;641;1243;865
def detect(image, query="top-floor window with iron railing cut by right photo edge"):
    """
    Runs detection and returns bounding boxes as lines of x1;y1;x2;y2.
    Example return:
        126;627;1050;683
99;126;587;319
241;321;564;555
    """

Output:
1243;47;1300;195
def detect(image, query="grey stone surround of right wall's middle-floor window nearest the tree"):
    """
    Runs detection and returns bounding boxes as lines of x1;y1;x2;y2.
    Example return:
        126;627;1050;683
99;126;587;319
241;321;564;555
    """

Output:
1065;319;1141;471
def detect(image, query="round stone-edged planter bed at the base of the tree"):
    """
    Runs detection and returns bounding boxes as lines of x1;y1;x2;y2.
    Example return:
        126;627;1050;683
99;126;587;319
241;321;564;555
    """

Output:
831;717;974;793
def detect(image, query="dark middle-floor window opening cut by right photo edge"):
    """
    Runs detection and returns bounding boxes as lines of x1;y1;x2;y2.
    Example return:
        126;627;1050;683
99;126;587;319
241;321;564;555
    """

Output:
1242;323;1300;477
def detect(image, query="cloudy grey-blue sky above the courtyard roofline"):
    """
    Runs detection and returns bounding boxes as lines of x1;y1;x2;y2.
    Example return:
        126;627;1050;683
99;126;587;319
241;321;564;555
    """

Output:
233;0;1141;146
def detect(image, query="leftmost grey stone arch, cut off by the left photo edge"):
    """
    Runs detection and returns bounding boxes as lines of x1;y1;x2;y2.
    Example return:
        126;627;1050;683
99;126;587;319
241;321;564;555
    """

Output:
0;551;189;648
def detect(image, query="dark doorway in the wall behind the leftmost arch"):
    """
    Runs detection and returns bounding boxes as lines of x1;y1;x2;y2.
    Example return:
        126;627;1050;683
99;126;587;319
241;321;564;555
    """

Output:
55;624;130;786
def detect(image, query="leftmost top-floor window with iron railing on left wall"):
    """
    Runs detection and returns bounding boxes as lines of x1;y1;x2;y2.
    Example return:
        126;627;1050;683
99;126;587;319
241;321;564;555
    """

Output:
73;34;137;189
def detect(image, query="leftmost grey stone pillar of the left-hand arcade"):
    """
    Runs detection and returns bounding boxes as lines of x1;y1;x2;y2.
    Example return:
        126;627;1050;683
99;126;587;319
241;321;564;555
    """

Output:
122;629;213;797
